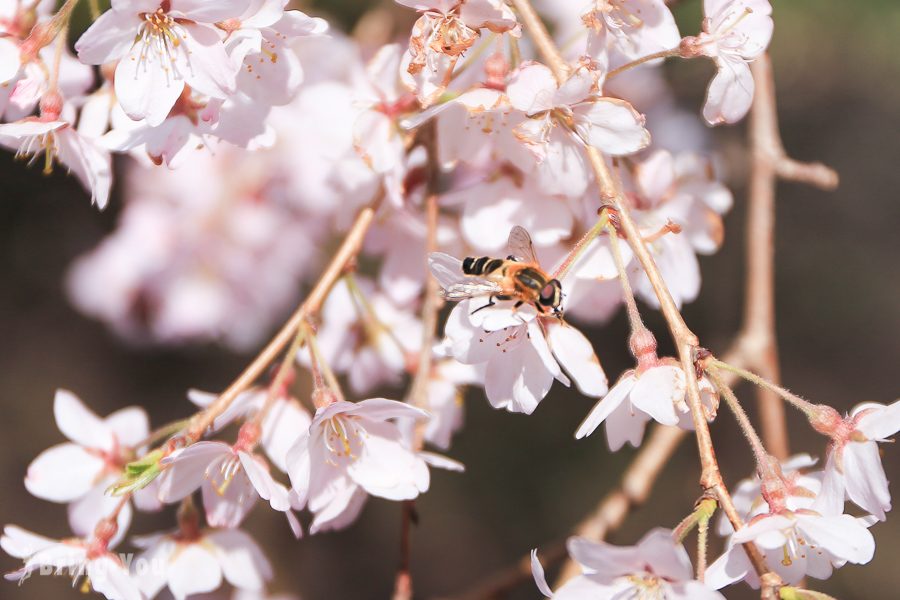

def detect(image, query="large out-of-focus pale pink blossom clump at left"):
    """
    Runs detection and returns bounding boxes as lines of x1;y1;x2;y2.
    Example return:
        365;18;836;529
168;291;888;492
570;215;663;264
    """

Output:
67;148;320;349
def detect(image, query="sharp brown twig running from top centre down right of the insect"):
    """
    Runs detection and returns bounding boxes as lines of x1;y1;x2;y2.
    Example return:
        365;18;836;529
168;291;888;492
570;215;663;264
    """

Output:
512;0;777;584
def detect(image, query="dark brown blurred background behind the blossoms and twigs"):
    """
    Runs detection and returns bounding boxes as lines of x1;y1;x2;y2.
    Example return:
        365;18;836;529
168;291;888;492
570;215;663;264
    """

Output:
0;0;900;600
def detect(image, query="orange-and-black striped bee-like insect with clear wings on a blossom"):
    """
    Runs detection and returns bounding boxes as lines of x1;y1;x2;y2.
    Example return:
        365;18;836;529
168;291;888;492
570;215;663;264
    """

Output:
428;225;562;316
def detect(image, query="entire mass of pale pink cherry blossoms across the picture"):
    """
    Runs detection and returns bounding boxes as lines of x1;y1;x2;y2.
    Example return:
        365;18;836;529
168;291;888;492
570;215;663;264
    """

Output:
0;0;900;600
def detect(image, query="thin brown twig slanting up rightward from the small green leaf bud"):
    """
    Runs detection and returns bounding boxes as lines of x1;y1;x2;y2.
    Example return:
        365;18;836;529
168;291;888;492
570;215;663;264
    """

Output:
185;195;380;444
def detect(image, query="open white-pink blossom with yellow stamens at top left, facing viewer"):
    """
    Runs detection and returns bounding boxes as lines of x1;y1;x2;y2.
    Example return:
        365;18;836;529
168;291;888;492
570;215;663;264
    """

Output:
75;0;249;126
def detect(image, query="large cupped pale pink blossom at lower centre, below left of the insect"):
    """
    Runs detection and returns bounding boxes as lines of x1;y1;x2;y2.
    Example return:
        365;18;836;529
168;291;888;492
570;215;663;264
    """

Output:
288;398;430;533
